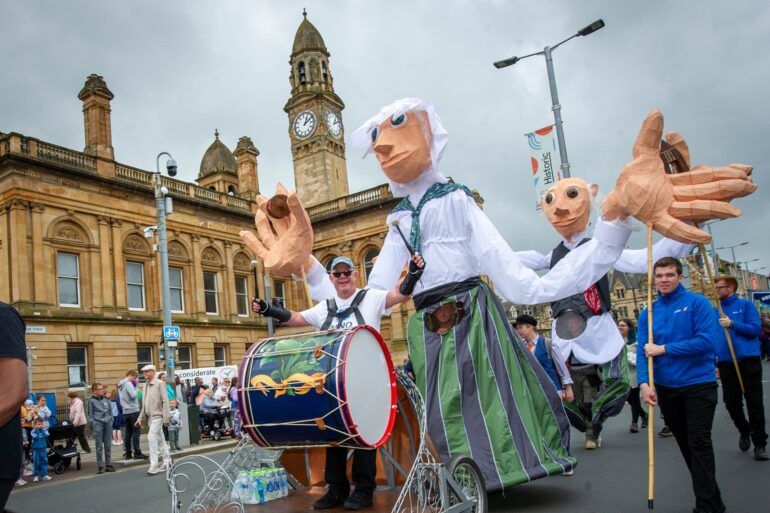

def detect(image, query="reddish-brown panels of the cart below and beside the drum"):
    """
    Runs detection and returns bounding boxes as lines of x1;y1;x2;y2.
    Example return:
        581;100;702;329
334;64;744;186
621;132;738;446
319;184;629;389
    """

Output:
281;374;420;486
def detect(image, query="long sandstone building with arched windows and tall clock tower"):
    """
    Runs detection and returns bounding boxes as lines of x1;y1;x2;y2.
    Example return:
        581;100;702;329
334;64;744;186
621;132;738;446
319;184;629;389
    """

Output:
0;11;413;397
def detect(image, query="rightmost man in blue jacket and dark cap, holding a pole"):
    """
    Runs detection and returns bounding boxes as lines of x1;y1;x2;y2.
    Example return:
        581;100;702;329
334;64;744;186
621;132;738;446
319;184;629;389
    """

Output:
716;276;768;461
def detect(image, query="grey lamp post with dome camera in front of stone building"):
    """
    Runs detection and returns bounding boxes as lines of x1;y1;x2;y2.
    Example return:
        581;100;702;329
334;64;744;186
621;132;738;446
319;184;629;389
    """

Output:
153;151;177;389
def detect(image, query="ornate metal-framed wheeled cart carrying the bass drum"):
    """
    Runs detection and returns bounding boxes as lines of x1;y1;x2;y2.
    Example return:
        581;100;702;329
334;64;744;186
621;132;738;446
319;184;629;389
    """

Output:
166;369;488;513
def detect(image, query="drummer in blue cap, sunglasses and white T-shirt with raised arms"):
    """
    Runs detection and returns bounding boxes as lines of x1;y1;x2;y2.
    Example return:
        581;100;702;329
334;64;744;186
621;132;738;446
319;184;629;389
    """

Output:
251;254;425;510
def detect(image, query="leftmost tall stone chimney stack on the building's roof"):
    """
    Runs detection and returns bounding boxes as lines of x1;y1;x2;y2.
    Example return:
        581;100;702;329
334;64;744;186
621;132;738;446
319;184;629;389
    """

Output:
78;74;115;160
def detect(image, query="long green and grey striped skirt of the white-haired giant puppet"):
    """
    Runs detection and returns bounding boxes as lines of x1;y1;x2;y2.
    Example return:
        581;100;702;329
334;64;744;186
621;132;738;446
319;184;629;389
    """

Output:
407;281;575;492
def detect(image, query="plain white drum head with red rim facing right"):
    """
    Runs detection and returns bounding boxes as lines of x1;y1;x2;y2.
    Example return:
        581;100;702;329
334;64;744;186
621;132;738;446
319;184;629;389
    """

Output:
344;327;396;447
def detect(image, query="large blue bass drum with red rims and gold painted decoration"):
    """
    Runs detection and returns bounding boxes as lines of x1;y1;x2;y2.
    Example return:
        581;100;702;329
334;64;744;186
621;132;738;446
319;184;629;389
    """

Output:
238;326;396;449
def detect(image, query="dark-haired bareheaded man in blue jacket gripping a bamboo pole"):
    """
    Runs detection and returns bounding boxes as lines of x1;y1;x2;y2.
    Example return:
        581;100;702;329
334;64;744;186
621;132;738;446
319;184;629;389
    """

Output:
636;257;725;513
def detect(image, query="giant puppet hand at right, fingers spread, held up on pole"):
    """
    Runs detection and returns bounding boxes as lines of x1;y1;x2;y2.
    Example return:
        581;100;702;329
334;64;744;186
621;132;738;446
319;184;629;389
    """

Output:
602;109;757;243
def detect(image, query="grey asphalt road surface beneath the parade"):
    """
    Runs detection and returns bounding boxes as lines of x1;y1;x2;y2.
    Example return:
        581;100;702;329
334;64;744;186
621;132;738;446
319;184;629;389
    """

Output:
8;372;770;513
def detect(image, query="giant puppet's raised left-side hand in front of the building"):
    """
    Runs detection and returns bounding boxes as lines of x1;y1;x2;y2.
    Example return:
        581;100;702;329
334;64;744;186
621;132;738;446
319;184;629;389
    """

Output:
240;183;314;276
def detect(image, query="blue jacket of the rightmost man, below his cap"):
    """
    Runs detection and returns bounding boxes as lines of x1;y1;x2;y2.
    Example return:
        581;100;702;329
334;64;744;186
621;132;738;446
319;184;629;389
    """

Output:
715;294;762;362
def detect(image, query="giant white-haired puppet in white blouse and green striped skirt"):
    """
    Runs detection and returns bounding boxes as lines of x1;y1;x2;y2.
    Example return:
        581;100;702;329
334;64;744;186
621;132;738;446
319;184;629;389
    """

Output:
244;98;751;491
